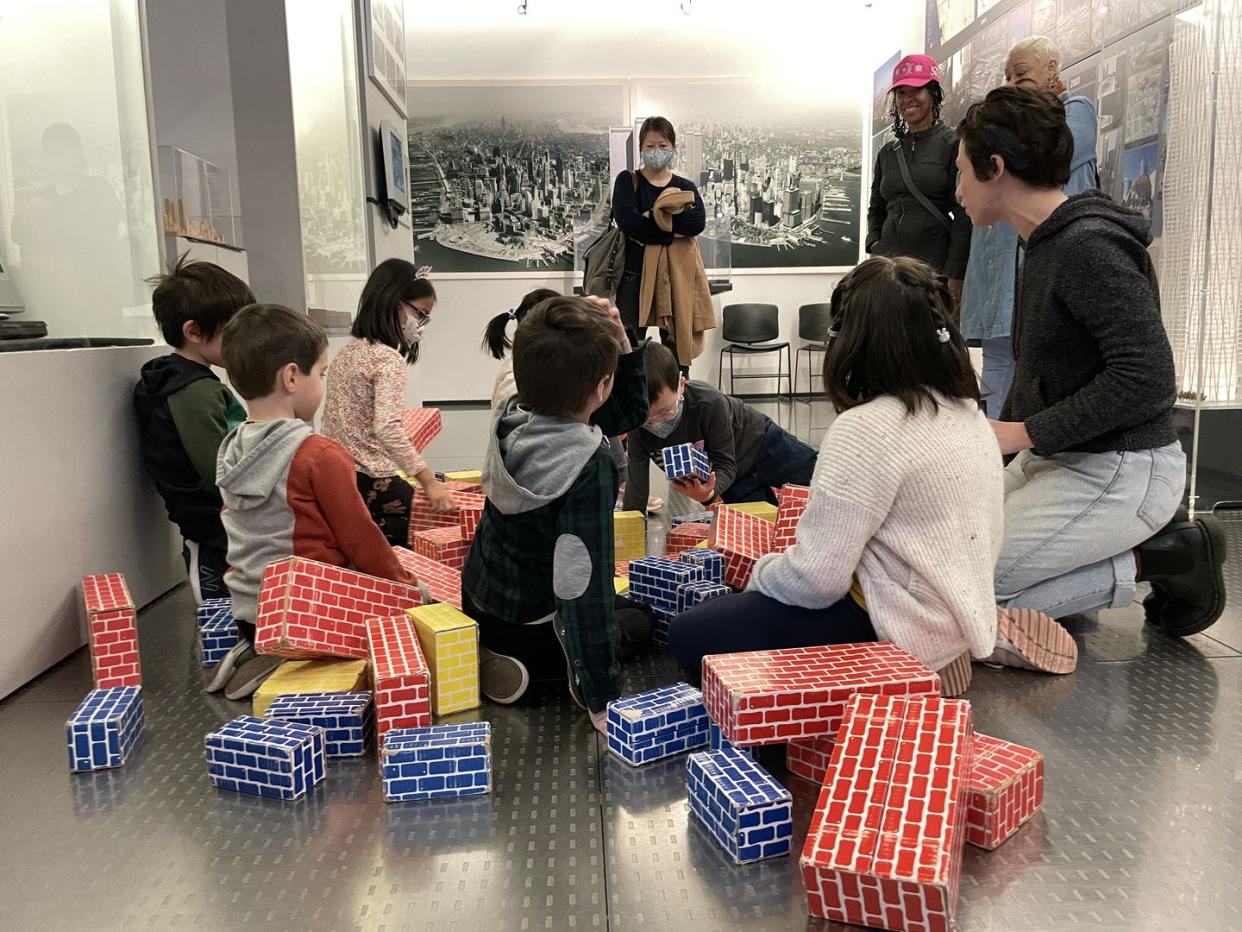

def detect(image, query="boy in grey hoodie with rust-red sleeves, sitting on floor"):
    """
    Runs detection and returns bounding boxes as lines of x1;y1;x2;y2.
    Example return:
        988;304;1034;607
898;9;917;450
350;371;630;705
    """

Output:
216;304;414;700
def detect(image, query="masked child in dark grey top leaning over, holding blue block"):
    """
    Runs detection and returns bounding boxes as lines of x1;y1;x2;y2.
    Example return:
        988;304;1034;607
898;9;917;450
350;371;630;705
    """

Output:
623;343;816;509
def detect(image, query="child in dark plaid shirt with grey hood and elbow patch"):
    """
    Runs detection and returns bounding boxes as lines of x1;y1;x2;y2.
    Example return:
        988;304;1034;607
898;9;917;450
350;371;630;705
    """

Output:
462;296;647;731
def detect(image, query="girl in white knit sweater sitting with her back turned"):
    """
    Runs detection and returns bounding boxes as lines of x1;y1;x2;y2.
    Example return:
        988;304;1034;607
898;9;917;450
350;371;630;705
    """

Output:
669;257;1073;688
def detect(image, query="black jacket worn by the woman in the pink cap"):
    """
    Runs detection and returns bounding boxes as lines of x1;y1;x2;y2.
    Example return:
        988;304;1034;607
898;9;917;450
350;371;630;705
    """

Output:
867;123;970;278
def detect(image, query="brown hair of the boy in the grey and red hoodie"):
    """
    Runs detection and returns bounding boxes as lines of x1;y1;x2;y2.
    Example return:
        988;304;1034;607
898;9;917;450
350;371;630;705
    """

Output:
222;304;328;401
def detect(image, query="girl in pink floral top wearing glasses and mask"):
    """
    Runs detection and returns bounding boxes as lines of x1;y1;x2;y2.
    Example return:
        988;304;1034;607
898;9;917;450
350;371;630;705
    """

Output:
323;258;453;547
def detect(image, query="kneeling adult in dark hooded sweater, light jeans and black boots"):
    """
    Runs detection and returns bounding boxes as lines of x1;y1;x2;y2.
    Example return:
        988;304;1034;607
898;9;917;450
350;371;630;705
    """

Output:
958;87;1225;636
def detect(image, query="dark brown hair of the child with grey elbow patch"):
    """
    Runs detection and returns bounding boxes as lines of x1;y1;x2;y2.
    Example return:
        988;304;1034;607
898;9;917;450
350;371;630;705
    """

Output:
513;295;620;418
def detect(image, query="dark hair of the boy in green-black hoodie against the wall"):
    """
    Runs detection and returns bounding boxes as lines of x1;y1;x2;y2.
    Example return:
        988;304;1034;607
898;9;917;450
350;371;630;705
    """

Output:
147;254;255;348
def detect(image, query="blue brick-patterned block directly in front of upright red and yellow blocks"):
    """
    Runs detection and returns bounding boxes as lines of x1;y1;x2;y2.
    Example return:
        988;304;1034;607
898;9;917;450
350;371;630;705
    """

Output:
381;722;492;803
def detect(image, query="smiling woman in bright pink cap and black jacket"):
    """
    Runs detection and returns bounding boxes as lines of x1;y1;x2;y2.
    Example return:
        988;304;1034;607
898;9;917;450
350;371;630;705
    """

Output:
867;55;970;301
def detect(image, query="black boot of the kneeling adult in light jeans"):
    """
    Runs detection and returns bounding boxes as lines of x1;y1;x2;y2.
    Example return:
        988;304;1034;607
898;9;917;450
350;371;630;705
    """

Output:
1138;517;1226;637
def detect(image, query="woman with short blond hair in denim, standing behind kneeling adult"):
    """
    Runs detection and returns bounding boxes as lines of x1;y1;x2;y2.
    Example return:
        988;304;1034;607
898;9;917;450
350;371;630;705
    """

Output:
961;36;1099;419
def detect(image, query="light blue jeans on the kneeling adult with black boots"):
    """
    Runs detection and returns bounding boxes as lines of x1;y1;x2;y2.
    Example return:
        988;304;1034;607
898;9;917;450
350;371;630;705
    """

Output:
995;444;1186;618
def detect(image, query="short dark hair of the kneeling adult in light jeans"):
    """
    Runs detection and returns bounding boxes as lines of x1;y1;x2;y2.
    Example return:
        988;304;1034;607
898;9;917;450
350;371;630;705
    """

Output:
958;86;1074;188
